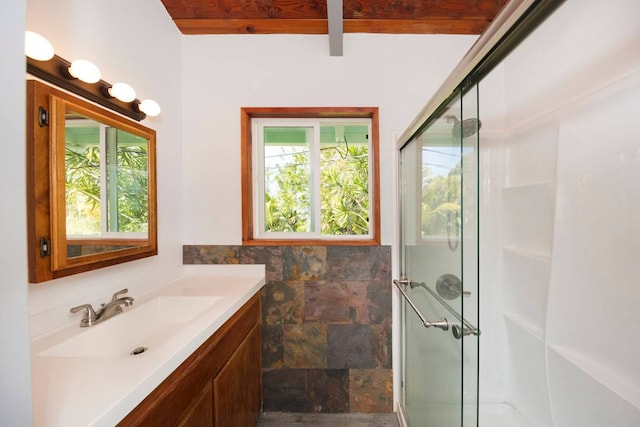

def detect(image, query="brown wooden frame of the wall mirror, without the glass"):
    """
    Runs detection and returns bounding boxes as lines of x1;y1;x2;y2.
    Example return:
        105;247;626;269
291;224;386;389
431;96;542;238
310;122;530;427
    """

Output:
27;80;158;283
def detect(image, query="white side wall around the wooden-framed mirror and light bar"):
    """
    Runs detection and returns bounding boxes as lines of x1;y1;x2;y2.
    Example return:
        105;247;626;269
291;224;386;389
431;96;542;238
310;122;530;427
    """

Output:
25;0;183;342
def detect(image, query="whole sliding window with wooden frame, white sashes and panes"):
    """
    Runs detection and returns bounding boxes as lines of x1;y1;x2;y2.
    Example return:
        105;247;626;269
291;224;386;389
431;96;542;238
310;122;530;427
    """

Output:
242;108;380;244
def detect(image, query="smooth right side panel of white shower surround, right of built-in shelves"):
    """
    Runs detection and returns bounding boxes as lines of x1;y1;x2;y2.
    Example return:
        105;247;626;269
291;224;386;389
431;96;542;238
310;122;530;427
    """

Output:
546;72;640;427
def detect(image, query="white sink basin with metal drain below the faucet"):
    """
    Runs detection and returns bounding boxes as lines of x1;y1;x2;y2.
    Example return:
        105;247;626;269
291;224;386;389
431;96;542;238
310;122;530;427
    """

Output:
39;296;223;358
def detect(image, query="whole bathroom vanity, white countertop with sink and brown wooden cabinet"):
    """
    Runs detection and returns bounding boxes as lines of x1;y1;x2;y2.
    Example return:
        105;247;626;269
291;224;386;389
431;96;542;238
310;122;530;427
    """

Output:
32;275;264;426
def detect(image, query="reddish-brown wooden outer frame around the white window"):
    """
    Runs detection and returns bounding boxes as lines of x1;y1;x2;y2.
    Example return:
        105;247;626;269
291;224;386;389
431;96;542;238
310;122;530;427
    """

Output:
240;107;380;246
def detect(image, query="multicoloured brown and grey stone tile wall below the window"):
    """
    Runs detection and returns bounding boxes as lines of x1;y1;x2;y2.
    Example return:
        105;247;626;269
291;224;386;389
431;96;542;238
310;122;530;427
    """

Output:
183;245;393;412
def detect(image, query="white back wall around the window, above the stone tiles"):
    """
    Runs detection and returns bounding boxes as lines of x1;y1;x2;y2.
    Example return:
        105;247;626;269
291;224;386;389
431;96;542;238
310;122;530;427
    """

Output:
182;34;476;244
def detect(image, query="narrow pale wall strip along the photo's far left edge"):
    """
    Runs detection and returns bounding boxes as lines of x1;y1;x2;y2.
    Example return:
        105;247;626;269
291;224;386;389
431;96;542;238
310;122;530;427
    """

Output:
0;0;32;426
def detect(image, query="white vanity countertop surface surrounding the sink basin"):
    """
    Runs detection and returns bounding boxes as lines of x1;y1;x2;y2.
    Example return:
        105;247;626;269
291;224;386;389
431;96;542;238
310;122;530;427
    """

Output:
31;273;264;427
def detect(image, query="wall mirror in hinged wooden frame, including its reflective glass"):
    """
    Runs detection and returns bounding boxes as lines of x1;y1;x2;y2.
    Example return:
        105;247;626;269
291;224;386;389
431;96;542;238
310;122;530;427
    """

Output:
27;80;158;283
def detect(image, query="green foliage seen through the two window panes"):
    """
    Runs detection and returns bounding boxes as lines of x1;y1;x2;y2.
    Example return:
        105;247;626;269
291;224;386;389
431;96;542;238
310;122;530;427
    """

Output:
265;146;369;235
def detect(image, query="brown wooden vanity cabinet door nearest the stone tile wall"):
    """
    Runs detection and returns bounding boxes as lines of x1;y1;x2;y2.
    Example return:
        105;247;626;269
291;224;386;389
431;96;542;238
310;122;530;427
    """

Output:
213;324;262;427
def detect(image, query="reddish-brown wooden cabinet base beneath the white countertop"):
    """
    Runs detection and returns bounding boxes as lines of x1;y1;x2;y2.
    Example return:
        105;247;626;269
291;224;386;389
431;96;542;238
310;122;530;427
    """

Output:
118;294;262;427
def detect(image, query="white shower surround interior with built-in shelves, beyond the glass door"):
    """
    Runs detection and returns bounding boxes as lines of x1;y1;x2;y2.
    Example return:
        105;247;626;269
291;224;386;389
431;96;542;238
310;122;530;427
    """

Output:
480;0;640;427
